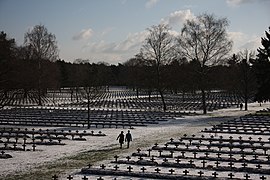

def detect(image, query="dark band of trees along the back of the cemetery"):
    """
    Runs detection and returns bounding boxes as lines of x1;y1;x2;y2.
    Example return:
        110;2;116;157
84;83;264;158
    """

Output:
0;21;270;110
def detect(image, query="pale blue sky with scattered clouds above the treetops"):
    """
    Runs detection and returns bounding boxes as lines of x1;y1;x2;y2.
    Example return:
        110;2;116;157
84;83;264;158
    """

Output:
0;0;270;64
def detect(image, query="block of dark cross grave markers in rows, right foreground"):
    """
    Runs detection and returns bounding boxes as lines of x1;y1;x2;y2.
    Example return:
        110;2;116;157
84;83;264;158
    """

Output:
76;112;270;179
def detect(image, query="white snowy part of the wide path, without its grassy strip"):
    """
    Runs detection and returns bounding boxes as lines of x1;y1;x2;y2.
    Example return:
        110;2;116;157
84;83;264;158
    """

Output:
0;103;270;179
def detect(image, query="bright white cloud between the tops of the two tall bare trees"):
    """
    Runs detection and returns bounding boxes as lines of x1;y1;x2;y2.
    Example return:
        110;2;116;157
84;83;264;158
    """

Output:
161;9;195;27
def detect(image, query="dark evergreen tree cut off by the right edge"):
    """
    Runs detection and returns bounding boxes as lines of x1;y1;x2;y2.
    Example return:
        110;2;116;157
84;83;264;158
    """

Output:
253;27;270;102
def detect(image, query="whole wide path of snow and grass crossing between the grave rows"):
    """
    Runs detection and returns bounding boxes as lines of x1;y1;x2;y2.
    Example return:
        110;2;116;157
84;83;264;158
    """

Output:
0;103;269;180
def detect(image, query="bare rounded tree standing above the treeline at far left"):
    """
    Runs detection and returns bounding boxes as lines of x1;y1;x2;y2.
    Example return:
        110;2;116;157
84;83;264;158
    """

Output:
24;25;58;105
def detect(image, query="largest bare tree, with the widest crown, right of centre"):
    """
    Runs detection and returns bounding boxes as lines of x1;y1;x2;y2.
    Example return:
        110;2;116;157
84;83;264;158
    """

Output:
178;14;232;114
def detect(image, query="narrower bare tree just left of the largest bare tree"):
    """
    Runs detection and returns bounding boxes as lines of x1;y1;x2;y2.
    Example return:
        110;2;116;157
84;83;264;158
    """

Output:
141;24;174;111
